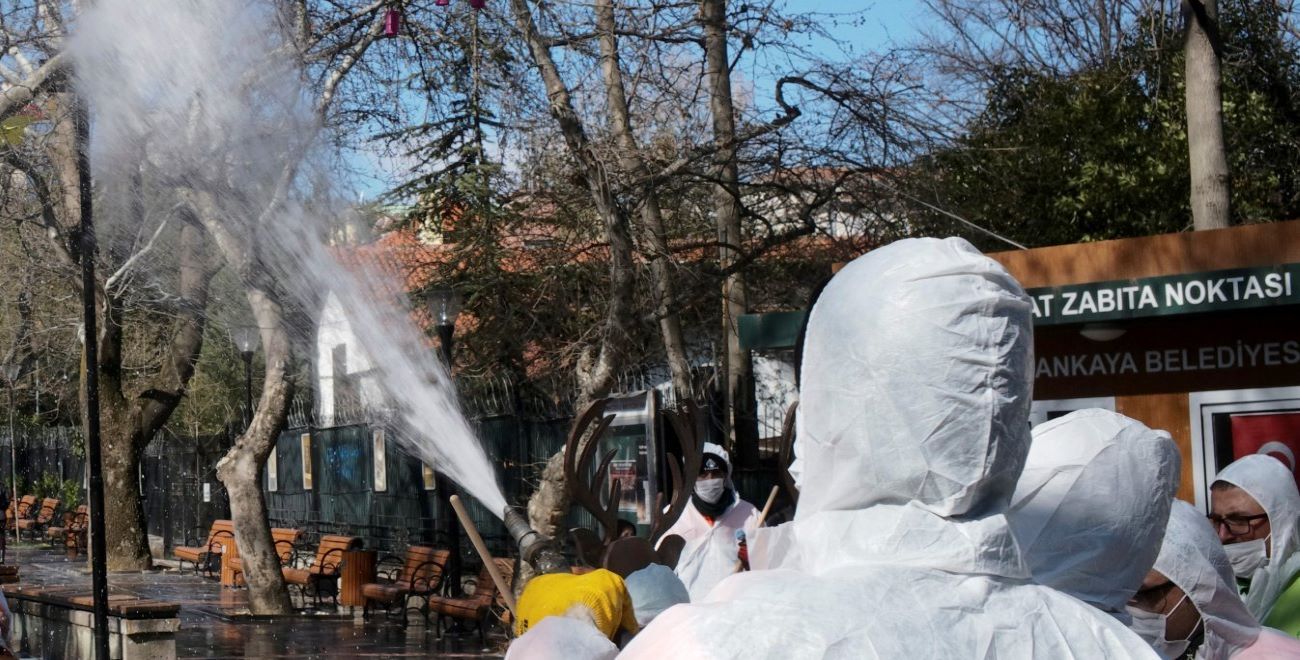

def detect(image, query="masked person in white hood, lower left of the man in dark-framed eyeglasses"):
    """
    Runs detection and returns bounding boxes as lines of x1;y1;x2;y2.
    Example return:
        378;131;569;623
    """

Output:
1128;501;1300;660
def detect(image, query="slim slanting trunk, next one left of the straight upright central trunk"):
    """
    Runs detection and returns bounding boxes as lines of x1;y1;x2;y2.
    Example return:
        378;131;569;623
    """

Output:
595;0;690;398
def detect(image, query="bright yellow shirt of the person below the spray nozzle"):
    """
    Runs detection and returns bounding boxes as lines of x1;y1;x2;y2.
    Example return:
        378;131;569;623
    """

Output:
515;568;637;639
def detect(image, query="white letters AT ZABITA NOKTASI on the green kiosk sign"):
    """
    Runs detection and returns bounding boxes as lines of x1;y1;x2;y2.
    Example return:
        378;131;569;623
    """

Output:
1030;272;1300;320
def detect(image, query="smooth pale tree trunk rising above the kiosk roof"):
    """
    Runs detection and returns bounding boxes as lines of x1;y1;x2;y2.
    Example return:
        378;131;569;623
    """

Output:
1183;0;1231;230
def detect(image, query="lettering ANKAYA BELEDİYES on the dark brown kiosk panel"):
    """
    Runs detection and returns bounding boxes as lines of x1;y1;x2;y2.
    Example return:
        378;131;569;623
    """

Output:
1034;339;1300;378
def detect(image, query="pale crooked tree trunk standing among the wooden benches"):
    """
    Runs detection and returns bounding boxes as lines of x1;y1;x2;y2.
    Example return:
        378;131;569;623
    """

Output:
217;282;293;615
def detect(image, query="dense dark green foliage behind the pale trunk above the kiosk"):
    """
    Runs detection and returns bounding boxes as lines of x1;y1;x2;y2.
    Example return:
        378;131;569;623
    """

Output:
914;0;1300;248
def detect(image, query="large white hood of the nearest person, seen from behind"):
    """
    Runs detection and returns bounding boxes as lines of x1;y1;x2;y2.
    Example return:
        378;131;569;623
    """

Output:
794;239;1034;518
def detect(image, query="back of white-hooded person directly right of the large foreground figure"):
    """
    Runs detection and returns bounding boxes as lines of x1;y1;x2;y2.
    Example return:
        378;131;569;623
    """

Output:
1006;409;1182;624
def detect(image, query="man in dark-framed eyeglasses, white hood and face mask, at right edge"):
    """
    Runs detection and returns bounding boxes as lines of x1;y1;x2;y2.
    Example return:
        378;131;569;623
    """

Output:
1209;453;1300;637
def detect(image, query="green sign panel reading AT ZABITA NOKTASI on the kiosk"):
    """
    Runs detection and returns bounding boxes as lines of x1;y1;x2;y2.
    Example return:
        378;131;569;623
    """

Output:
1027;264;1300;325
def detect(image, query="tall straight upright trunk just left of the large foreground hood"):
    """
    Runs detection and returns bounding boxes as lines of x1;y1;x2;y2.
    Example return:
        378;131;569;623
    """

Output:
699;0;758;465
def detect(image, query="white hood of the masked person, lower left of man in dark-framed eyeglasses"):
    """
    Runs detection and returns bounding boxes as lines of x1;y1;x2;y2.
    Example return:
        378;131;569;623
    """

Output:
1156;500;1260;659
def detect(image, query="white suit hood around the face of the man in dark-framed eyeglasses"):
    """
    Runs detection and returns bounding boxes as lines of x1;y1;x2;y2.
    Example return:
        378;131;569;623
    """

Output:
1210;453;1300;621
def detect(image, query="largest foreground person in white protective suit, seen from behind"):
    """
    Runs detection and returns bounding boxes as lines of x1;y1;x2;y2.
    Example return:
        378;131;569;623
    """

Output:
620;238;1156;660
